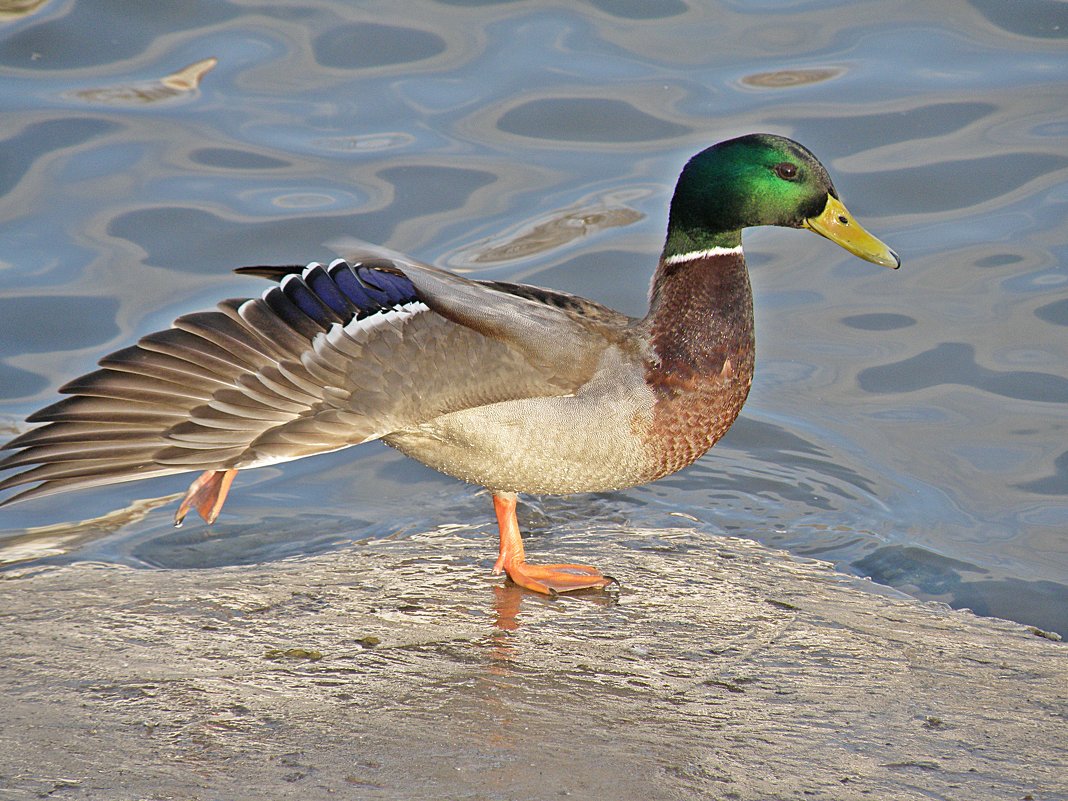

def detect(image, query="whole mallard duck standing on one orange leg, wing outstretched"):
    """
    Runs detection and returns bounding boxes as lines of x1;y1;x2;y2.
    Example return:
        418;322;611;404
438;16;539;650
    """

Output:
0;134;900;594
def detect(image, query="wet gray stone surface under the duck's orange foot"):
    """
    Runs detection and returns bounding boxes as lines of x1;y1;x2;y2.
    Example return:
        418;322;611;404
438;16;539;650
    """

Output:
0;530;1068;801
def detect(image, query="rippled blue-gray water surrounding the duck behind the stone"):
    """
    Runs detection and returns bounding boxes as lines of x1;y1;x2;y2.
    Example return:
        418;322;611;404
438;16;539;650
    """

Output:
0;0;1068;631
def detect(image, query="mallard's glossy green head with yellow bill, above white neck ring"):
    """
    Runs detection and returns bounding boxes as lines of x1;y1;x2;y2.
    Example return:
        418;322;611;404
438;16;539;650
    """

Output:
664;134;901;268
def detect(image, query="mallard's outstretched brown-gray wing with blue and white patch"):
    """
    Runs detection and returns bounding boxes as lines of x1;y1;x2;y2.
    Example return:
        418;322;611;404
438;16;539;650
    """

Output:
0;258;627;504
